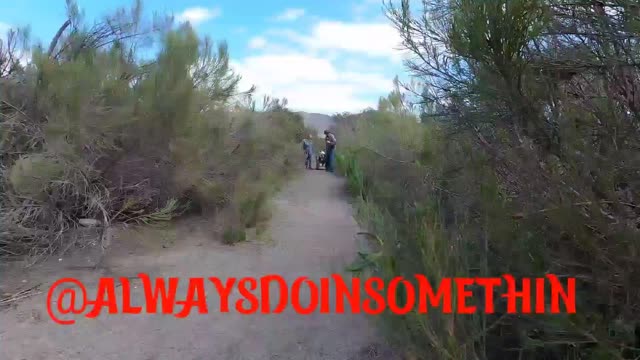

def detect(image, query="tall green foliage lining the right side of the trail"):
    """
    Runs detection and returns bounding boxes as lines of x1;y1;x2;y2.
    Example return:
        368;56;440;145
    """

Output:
338;0;640;359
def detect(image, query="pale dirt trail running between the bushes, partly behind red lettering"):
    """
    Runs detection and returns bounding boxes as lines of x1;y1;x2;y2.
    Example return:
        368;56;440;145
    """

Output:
0;171;389;360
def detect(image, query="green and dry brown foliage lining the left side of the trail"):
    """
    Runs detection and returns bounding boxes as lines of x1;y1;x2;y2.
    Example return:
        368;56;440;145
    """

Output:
0;1;306;257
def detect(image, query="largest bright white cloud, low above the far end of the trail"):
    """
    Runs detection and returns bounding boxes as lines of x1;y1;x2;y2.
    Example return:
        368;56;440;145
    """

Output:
232;14;403;114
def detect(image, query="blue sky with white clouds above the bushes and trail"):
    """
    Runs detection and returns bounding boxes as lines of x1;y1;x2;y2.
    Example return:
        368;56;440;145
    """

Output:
0;0;404;113
